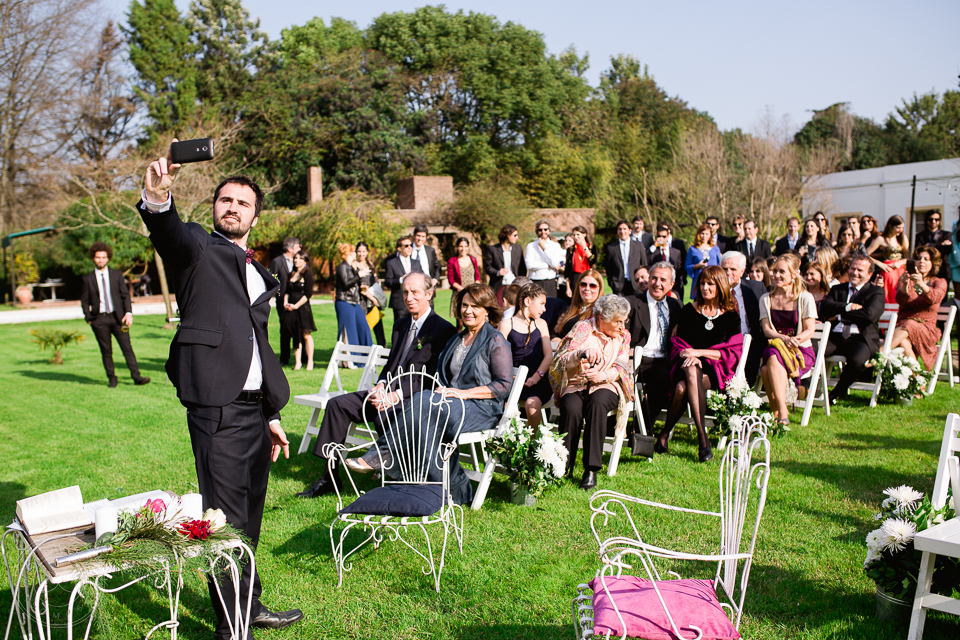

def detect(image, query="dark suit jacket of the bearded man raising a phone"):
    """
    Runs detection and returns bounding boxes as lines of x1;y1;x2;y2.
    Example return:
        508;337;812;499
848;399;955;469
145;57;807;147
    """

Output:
137;201;290;420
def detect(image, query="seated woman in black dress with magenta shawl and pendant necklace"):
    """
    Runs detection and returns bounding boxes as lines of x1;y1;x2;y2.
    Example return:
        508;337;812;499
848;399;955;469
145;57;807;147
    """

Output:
654;266;743;462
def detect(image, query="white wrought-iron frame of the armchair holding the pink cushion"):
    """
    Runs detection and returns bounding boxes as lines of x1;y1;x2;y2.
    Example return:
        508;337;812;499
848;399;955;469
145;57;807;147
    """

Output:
573;417;770;640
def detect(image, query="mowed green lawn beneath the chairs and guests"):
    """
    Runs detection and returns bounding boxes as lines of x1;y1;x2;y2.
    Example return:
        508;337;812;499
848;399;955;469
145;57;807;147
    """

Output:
0;293;960;640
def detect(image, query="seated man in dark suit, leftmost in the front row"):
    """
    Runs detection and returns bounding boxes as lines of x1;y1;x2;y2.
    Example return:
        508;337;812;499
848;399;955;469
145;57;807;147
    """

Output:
297;271;457;498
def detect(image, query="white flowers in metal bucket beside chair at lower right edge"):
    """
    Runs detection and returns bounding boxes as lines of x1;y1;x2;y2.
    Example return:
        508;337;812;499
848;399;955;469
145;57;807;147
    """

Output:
863;485;960;622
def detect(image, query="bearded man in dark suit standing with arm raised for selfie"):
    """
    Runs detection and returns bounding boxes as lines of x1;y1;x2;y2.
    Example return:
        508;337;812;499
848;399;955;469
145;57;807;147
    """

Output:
137;152;303;638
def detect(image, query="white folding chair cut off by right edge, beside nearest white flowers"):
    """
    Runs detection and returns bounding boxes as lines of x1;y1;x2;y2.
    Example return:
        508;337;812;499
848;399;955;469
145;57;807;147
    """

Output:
907;413;960;640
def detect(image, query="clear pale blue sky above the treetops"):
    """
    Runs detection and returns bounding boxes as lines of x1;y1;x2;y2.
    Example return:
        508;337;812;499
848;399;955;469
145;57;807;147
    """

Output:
104;0;960;131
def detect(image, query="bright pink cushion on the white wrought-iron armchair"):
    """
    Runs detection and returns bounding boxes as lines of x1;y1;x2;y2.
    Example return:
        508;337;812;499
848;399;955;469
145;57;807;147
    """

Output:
590;576;740;640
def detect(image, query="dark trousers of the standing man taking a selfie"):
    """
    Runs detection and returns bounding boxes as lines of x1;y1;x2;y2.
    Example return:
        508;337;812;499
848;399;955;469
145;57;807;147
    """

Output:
187;401;271;638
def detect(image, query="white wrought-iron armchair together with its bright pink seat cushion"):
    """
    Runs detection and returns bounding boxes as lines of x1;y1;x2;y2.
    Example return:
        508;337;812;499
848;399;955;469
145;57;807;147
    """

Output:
573;417;770;640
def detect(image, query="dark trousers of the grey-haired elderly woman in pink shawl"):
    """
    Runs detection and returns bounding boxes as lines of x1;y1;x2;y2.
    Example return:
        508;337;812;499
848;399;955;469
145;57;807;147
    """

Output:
560;389;619;471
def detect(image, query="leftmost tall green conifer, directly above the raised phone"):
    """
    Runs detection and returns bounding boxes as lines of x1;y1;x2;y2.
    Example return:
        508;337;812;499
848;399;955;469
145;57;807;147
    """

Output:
121;0;197;145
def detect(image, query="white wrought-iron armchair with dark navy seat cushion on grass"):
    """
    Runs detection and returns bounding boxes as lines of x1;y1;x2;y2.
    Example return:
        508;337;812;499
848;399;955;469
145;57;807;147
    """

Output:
323;371;464;592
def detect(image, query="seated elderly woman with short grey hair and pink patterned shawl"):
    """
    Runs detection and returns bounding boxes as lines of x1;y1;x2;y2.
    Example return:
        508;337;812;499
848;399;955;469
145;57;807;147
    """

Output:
550;295;633;490
